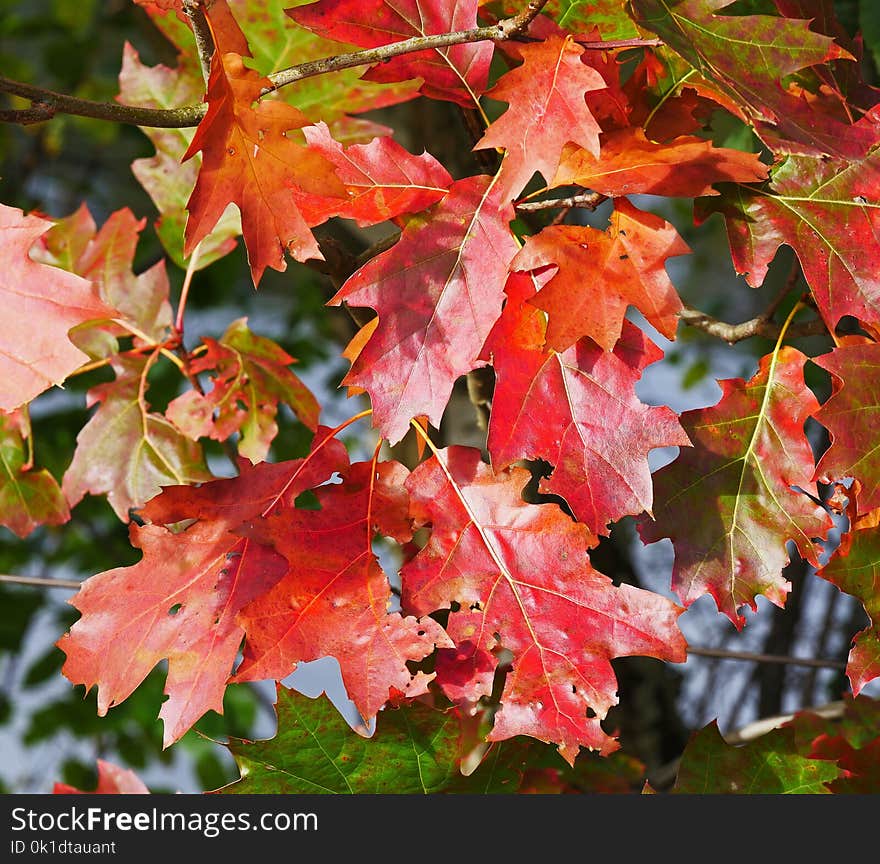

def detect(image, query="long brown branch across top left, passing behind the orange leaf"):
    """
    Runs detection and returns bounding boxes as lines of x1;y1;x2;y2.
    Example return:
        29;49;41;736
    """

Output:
0;0;547;129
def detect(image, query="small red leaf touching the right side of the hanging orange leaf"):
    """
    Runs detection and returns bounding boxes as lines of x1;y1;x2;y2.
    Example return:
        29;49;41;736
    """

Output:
300;123;452;227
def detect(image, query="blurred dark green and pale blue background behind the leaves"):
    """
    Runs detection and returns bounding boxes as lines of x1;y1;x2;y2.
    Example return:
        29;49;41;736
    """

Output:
0;0;880;792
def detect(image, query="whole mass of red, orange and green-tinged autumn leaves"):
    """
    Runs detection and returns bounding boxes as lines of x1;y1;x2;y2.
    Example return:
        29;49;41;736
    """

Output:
0;0;880;784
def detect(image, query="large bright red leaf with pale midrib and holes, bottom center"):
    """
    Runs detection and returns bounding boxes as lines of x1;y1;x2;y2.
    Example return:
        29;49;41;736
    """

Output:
401;447;685;763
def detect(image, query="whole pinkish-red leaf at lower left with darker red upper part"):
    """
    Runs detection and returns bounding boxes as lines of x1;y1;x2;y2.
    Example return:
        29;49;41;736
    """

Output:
58;430;347;747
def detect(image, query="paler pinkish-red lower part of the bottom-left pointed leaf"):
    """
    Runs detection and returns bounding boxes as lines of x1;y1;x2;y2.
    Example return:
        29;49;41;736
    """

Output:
58;523;287;747
